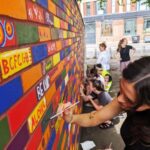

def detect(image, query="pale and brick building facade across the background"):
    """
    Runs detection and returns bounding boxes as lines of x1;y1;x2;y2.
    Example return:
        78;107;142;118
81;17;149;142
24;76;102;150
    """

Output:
79;0;150;51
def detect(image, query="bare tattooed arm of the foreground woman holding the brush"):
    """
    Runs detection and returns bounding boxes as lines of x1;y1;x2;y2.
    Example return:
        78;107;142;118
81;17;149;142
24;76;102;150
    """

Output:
64;99;122;127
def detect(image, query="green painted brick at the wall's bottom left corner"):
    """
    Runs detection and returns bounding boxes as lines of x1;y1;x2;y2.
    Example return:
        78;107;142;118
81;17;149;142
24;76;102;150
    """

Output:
0;117;10;150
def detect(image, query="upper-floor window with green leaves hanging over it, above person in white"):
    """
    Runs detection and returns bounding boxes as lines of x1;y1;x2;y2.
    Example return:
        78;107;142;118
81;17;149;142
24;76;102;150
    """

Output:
96;1;106;15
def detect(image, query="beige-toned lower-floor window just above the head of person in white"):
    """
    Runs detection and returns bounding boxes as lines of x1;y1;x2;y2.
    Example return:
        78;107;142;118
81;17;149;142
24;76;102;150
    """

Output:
101;20;113;36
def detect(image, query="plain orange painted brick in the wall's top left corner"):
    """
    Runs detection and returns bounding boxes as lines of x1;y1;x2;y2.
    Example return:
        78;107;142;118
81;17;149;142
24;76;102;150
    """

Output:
0;0;27;19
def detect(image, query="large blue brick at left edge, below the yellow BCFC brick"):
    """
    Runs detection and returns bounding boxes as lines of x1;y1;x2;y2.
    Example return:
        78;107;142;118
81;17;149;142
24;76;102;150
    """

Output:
0;77;23;115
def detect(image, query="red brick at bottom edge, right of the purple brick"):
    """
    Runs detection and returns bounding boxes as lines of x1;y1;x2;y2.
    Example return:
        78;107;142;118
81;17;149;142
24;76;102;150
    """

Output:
26;126;42;150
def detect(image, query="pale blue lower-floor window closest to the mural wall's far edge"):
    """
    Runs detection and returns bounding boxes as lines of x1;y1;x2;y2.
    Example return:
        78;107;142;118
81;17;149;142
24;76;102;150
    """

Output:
85;22;96;44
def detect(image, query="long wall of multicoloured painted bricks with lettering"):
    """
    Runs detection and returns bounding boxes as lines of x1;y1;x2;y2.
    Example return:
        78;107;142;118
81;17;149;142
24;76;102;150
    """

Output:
0;0;84;150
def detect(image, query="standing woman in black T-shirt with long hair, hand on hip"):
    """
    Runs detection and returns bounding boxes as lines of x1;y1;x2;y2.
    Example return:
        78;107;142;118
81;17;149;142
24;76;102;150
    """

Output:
117;38;135;72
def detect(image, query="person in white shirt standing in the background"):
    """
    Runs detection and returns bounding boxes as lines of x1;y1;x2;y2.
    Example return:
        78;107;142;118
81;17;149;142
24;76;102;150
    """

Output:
96;42;110;70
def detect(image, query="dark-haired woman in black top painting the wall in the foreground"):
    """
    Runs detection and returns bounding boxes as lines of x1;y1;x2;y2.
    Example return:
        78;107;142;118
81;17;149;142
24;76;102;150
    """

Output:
64;56;150;150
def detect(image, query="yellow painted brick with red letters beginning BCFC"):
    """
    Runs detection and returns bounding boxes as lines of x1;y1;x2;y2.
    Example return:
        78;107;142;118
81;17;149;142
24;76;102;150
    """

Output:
0;47;32;79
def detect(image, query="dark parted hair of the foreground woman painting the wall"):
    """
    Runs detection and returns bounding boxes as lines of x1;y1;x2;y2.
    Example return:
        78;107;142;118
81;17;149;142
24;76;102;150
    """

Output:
123;56;150;105
